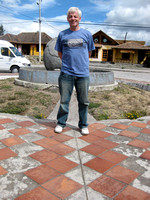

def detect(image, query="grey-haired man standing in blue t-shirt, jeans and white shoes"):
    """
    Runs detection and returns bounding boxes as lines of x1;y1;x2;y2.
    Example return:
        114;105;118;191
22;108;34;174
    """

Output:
55;7;95;135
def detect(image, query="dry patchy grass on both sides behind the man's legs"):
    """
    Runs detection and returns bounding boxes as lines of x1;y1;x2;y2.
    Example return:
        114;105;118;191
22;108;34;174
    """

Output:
0;79;150;120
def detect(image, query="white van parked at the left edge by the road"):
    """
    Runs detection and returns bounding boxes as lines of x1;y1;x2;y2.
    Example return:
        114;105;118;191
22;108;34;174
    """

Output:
0;40;31;73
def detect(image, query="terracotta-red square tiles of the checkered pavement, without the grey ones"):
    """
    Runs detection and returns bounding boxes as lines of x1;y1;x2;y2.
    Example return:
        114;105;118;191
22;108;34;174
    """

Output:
0;118;150;200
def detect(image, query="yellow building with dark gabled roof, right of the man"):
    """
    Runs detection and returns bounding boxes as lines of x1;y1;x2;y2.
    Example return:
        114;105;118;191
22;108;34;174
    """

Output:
90;30;150;64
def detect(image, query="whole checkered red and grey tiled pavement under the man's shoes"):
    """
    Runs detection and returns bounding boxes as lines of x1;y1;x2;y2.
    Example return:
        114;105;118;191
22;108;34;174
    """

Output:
0;114;150;200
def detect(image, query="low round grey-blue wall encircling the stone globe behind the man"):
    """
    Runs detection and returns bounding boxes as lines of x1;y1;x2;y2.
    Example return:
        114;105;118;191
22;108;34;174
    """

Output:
15;67;118;91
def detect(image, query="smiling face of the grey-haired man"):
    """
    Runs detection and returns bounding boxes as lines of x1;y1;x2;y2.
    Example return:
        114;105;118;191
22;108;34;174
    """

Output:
67;12;81;27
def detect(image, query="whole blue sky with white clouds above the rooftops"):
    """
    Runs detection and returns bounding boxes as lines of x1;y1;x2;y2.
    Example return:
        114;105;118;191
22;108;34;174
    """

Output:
0;0;150;44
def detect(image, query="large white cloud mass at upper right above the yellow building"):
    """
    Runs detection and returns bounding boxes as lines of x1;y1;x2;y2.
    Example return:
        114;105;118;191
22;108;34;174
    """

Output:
88;0;150;45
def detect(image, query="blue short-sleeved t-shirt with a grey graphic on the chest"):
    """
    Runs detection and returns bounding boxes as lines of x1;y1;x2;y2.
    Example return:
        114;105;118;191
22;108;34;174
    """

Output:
55;28;95;77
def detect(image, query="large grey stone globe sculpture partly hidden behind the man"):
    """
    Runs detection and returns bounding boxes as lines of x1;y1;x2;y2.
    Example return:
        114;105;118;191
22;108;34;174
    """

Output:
43;38;61;70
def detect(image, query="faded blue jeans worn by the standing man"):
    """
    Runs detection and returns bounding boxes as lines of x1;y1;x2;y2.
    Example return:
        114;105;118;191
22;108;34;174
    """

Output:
57;72;89;128
